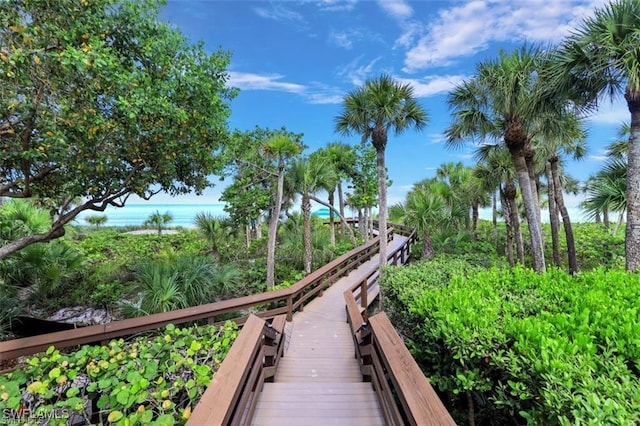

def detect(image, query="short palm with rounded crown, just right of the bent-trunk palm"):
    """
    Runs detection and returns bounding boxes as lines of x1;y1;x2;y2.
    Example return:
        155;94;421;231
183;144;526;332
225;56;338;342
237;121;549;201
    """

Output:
287;157;332;274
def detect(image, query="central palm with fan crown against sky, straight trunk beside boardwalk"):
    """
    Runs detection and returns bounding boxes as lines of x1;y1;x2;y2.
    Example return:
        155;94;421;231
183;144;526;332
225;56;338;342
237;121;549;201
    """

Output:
336;74;428;266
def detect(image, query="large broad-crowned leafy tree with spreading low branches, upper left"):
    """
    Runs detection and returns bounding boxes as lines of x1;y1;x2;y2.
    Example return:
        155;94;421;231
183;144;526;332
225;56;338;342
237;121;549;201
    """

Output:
0;0;235;258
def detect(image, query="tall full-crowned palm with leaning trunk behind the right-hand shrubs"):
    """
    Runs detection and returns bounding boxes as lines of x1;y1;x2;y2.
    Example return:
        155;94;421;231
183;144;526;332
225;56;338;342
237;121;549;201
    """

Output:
446;47;557;272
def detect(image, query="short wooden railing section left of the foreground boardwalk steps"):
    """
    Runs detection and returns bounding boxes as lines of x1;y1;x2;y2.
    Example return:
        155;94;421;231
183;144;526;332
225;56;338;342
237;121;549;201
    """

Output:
187;315;285;426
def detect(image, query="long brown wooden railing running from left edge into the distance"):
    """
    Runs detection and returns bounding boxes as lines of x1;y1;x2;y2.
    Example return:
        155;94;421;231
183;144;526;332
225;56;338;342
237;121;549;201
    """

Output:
0;223;415;361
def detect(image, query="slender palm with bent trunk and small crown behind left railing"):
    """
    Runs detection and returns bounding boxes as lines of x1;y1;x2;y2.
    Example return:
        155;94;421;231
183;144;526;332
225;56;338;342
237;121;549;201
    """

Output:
265;134;302;287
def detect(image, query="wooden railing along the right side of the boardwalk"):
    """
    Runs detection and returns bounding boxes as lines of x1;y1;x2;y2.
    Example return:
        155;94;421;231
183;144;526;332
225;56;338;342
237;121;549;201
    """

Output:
344;231;455;426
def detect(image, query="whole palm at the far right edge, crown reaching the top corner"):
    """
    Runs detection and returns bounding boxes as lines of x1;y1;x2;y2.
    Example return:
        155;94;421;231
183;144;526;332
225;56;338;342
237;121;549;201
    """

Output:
551;0;640;271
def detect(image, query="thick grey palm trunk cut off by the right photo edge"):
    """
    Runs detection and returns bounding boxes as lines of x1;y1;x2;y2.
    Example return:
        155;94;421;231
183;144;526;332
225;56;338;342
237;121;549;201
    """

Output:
621;99;640;272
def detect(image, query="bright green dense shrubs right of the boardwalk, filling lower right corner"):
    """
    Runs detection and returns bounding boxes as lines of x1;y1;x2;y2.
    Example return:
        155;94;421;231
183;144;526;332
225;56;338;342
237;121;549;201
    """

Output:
383;262;640;425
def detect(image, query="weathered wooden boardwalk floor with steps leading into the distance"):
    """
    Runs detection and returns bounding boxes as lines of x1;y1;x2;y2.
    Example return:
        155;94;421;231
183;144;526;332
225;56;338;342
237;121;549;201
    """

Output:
252;234;406;426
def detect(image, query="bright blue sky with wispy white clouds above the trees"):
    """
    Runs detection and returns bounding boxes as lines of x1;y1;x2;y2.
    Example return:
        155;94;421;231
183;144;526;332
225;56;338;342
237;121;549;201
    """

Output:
145;0;629;213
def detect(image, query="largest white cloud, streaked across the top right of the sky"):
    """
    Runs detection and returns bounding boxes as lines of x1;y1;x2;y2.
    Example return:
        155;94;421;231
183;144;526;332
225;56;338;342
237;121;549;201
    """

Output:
396;0;603;72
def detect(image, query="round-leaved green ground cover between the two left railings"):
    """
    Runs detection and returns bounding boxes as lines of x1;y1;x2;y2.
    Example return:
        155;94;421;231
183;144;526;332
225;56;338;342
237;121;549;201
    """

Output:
0;323;238;426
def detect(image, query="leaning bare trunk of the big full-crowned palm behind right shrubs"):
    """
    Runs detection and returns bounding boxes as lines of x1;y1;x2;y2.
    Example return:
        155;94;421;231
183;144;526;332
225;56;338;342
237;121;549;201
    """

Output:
510;150;547;272
